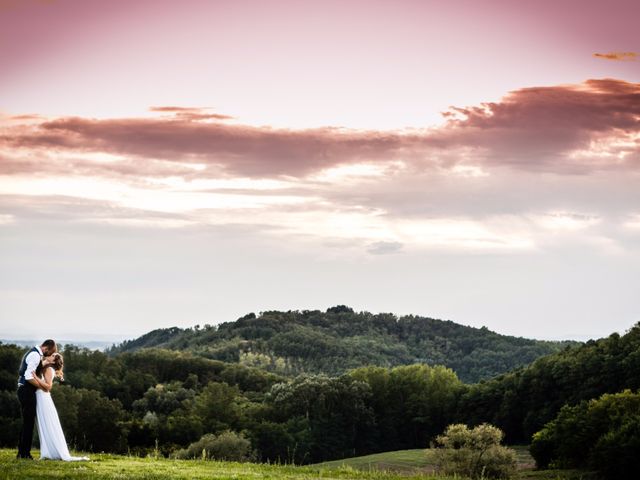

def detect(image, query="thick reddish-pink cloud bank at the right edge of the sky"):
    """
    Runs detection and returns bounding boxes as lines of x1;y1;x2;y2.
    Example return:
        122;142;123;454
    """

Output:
435;79;640;173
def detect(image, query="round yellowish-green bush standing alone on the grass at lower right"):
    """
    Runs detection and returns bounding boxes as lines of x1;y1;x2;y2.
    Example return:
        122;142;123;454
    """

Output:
433;424;516;479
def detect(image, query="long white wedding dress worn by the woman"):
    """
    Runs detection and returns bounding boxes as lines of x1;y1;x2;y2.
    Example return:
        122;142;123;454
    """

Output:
36;367;89;462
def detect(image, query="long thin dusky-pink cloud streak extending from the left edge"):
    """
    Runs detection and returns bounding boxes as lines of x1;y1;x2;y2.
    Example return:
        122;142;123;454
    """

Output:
0;116;430;177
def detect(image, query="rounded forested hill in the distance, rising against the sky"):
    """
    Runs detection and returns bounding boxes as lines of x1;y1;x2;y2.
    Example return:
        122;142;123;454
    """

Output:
109;305;575;382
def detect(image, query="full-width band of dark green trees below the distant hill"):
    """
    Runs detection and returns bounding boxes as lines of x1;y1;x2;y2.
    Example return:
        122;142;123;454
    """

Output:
0;324;640;463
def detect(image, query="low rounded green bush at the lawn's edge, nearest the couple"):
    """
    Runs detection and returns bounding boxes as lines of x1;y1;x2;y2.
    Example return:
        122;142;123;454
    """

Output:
174;430;254;462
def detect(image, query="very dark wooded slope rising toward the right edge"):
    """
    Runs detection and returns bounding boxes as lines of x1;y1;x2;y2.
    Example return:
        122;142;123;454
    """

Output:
460;323;640;443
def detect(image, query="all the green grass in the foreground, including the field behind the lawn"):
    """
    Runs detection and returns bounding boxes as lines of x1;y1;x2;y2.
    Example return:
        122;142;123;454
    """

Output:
0;447;591;480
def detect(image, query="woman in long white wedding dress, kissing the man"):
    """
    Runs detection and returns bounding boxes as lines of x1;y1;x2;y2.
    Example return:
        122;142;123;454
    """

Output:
33;353;89;462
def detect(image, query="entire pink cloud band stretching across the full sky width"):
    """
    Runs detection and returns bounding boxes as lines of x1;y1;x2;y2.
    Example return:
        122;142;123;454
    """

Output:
0;79;640;177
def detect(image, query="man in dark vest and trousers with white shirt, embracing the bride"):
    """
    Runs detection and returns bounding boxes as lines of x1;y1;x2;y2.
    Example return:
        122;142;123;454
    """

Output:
16;340;57;460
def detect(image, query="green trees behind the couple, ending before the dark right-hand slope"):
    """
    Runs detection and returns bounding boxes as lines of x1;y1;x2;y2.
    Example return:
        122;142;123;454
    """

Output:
0;345;464;463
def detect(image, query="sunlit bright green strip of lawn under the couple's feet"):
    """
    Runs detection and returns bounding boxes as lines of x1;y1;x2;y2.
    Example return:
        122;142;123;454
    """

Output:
0;449;456;480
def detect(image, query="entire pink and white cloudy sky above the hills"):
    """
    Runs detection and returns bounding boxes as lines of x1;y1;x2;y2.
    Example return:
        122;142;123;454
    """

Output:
0;0;640;340
